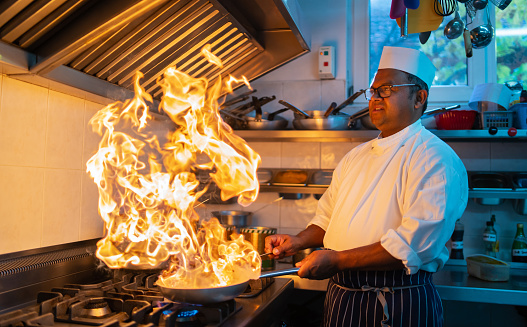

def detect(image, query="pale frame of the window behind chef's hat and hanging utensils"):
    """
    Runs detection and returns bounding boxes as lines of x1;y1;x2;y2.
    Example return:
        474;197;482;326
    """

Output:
350;0;497;104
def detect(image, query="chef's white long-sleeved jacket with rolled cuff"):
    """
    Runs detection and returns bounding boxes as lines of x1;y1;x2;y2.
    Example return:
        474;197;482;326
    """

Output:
308;120;468;274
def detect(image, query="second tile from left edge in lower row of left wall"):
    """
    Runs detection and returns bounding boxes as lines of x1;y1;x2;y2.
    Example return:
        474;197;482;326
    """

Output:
42;169;82;246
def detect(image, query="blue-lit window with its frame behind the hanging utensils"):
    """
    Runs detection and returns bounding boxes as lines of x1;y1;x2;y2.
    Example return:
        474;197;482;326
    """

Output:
352;0;527;102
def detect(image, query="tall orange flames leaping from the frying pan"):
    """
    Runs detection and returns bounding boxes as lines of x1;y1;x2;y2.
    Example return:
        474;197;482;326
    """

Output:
87;46;261;288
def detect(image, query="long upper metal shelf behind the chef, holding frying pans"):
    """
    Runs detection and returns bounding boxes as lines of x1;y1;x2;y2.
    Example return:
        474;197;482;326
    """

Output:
234;129;527;142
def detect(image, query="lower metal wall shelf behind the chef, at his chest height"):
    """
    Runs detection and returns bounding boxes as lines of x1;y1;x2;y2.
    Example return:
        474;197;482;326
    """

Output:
260;185;527;199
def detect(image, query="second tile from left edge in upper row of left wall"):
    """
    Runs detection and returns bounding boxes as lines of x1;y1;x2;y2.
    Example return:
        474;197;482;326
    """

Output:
46;91;84;169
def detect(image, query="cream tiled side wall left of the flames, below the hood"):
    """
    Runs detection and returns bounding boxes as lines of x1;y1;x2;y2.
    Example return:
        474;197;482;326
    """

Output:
0;75;104;253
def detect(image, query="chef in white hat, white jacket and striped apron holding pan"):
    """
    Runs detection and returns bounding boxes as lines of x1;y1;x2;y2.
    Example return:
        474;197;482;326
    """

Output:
266;47;468;326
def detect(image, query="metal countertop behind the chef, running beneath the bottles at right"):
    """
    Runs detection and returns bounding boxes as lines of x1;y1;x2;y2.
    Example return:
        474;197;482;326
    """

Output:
276;260;527;305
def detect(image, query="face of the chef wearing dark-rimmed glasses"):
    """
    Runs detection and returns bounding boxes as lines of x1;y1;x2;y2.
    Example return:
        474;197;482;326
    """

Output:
369;69;421;137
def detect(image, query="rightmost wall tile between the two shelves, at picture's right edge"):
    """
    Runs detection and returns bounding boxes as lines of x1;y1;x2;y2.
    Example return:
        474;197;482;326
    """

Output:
490;143;527;171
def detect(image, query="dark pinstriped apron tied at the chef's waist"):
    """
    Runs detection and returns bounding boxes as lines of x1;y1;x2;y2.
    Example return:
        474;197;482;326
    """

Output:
324;270;443;327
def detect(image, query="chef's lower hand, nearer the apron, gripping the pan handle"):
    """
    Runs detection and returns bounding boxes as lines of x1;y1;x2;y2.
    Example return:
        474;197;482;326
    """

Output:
296;250;339;279
